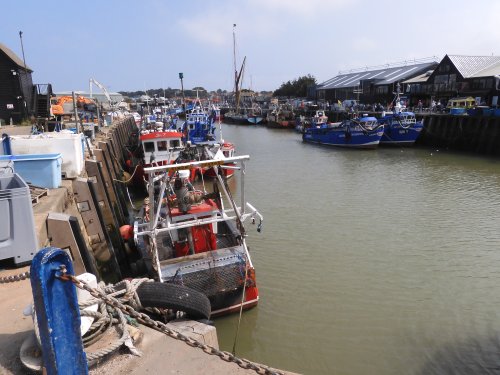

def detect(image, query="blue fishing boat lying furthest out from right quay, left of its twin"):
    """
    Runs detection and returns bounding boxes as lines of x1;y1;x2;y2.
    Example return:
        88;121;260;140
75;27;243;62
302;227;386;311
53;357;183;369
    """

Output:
302;116;384;148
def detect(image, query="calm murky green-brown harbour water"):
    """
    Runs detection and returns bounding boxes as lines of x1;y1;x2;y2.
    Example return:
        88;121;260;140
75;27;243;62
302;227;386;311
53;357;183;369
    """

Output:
216;125;500;375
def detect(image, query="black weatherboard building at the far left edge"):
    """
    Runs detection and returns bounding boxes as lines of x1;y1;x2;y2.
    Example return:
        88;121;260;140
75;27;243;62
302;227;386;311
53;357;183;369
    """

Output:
0;43;33;124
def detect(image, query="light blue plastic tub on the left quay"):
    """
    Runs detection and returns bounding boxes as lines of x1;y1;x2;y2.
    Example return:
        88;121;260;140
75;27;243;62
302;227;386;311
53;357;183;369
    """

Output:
0;154;62;189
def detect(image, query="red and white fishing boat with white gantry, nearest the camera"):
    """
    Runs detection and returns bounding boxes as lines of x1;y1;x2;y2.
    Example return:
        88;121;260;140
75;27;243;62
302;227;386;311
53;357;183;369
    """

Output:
134;156;263;317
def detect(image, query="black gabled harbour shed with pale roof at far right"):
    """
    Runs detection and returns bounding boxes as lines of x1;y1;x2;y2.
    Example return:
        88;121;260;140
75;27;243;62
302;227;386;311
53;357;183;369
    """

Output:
404;55;500;107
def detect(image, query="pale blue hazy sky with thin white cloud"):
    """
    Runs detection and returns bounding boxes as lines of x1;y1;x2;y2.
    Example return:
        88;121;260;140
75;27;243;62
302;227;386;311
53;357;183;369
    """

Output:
0;0;500;92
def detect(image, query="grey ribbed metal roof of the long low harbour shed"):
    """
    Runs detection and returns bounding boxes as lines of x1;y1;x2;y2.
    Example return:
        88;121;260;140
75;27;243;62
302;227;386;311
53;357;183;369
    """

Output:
318;62;436;90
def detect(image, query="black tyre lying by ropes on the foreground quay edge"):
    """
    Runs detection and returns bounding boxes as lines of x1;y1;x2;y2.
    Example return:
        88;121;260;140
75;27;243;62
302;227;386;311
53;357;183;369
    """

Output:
137;282;211;319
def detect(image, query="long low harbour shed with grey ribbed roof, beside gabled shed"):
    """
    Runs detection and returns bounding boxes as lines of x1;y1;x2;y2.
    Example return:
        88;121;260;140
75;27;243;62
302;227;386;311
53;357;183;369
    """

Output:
316;58;438;104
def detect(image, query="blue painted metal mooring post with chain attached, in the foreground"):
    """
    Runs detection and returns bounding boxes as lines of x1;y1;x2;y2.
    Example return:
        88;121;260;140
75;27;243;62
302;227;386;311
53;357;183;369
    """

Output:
31;247;88;375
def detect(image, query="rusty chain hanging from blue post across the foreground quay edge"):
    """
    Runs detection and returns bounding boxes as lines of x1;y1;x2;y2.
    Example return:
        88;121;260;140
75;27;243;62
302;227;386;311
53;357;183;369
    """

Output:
57;266;283;375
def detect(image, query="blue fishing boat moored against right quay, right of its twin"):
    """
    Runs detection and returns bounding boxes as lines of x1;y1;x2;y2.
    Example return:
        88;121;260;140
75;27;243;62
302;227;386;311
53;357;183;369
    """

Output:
378;83;424;146
